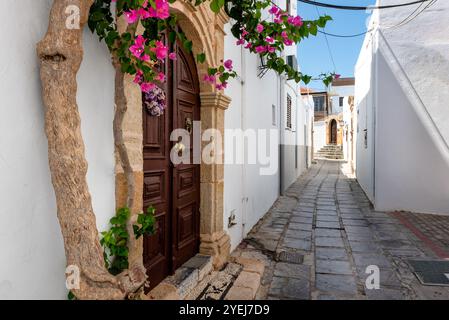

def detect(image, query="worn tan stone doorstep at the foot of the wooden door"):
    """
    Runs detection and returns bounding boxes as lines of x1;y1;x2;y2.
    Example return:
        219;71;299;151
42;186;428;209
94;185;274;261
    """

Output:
147;254;265;300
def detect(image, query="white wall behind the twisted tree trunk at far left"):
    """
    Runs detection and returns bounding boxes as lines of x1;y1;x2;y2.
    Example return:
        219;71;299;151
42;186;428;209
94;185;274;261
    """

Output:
0;0;115;299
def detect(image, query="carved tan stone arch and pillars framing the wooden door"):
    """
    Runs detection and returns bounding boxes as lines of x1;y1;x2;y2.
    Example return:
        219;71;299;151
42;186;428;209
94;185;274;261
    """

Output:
116;1;231;280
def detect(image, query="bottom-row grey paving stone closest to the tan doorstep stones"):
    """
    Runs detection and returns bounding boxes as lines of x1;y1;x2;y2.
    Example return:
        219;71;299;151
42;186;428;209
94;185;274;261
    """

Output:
268;277;310;300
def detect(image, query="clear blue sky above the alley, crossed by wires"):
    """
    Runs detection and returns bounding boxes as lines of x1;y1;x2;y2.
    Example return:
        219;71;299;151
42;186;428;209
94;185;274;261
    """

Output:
298;0;376;89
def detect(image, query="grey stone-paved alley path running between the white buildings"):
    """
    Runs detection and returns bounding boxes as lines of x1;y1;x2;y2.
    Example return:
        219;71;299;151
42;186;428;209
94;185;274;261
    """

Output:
233;161;449;300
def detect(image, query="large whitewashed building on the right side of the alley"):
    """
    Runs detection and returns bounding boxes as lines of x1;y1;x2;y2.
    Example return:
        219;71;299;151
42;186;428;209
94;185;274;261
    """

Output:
355;0;449;214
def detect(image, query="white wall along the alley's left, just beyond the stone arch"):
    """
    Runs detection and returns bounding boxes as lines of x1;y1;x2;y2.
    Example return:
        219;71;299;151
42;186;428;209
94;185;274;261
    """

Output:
223;1;306;249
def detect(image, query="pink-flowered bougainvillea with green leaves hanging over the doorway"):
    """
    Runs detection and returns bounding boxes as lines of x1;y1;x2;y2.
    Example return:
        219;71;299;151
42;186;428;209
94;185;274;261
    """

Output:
89;0;337;97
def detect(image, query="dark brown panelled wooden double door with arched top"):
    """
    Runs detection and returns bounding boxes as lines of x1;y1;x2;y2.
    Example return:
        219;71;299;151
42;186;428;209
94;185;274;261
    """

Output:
142;30;200;289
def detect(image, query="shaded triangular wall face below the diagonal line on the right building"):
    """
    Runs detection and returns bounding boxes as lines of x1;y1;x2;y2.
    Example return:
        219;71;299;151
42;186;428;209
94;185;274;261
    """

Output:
375;54;449;214
